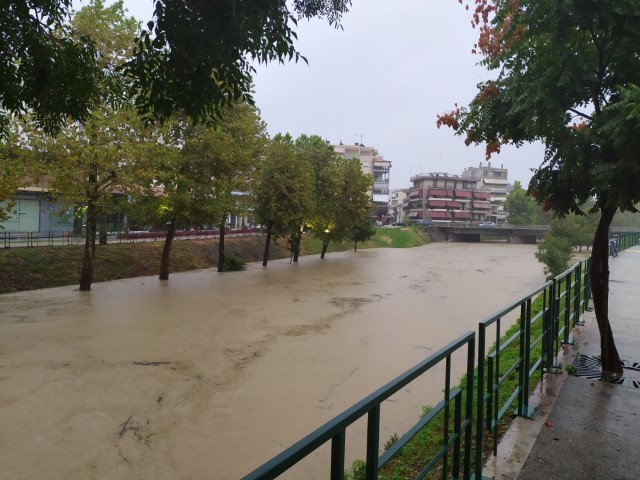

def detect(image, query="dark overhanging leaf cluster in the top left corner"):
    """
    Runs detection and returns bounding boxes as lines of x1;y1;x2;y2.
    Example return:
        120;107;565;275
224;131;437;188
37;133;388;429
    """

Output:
0;0;100;137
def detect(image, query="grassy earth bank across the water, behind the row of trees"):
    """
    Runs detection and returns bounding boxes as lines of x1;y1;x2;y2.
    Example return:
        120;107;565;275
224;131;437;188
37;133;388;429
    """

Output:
0;228;427;293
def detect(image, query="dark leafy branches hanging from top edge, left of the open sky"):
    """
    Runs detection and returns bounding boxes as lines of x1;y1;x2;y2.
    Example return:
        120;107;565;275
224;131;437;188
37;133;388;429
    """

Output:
127;0;351;125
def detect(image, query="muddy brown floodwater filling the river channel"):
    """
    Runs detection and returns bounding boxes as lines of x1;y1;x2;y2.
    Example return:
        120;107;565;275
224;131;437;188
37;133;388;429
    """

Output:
0;243;544;480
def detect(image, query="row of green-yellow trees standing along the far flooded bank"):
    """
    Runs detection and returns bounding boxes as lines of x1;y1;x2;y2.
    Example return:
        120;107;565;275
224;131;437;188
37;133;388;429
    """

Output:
0;0;372;291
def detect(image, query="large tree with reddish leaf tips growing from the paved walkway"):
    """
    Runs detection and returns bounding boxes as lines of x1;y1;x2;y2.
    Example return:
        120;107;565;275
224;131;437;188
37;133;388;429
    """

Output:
438;0;640;377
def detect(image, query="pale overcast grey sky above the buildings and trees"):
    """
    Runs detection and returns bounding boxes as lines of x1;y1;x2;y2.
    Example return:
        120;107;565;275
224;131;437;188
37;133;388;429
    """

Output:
111;0;543;188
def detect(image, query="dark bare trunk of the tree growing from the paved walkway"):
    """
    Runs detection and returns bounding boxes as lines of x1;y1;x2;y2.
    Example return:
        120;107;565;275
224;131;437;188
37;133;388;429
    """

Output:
589;207;622;378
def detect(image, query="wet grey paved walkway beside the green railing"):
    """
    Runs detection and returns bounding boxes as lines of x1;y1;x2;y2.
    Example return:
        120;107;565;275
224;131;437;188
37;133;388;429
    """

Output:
484;246;640;480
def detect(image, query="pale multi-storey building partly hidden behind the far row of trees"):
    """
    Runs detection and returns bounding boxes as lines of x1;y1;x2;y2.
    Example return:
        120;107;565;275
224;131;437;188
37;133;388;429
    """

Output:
331;142;391;223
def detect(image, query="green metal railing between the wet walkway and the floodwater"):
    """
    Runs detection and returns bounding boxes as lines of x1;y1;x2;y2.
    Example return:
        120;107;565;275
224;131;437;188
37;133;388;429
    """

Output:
244;233;640;480
